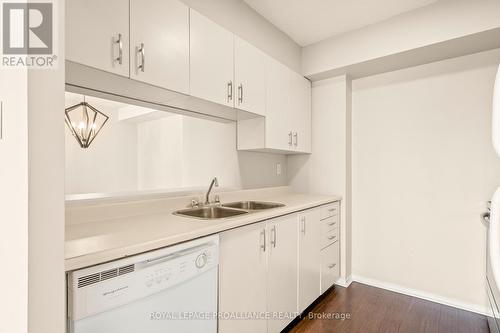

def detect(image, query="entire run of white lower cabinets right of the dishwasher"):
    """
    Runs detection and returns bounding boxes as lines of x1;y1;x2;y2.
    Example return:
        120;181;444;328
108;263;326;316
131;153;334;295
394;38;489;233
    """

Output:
219;201;339;333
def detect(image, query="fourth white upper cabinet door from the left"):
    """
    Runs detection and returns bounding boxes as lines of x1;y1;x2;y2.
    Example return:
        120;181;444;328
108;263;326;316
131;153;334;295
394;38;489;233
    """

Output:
234;36;267;115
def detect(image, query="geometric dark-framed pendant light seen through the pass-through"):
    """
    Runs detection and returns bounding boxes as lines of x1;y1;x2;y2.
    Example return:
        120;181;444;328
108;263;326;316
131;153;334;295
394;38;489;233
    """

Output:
65;96;109;148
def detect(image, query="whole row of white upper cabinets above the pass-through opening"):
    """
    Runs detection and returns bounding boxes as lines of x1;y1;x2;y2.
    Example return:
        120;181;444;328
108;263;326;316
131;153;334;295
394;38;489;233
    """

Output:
66;0;311;154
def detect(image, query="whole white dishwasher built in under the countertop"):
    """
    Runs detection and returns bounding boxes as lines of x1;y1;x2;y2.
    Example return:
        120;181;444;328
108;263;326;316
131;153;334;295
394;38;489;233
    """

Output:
68;236;219;333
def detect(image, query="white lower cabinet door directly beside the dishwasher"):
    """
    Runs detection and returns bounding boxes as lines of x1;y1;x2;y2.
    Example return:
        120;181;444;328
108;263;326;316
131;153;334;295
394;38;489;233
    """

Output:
219;222;269;333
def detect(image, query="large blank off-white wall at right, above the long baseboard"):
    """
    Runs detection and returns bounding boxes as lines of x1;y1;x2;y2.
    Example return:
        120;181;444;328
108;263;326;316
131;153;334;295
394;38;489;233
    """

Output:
352;50;500;311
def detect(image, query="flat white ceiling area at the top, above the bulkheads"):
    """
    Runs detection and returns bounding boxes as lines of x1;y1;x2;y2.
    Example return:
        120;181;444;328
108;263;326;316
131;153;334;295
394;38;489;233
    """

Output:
243;0;438;46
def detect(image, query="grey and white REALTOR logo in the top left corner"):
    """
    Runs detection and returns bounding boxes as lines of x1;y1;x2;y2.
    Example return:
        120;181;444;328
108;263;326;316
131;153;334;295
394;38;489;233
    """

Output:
2;1;57;68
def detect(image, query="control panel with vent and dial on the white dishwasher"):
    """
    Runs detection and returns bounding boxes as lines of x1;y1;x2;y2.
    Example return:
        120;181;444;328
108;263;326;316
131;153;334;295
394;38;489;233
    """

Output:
68;238;219;320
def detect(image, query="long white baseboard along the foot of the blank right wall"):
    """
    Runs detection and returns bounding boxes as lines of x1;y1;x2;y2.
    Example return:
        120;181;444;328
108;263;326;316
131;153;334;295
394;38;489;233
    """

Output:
352;275;492;316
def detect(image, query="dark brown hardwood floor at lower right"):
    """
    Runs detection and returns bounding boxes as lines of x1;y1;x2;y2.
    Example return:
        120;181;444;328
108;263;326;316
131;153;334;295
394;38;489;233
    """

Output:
290;282;489;333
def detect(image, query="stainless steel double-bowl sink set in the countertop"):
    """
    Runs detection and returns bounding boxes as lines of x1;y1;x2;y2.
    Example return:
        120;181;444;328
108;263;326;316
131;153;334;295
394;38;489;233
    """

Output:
174;201;285;220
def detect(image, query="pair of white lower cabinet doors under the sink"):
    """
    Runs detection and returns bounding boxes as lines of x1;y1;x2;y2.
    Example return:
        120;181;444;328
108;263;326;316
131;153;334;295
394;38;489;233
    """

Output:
219;214;297;333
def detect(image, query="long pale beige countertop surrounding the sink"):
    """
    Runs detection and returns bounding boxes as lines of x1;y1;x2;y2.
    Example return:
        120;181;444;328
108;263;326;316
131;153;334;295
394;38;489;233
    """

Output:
65;187;341;271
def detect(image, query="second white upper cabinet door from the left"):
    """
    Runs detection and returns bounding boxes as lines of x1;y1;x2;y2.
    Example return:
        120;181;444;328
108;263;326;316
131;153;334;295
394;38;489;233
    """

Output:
130;0;189;94
